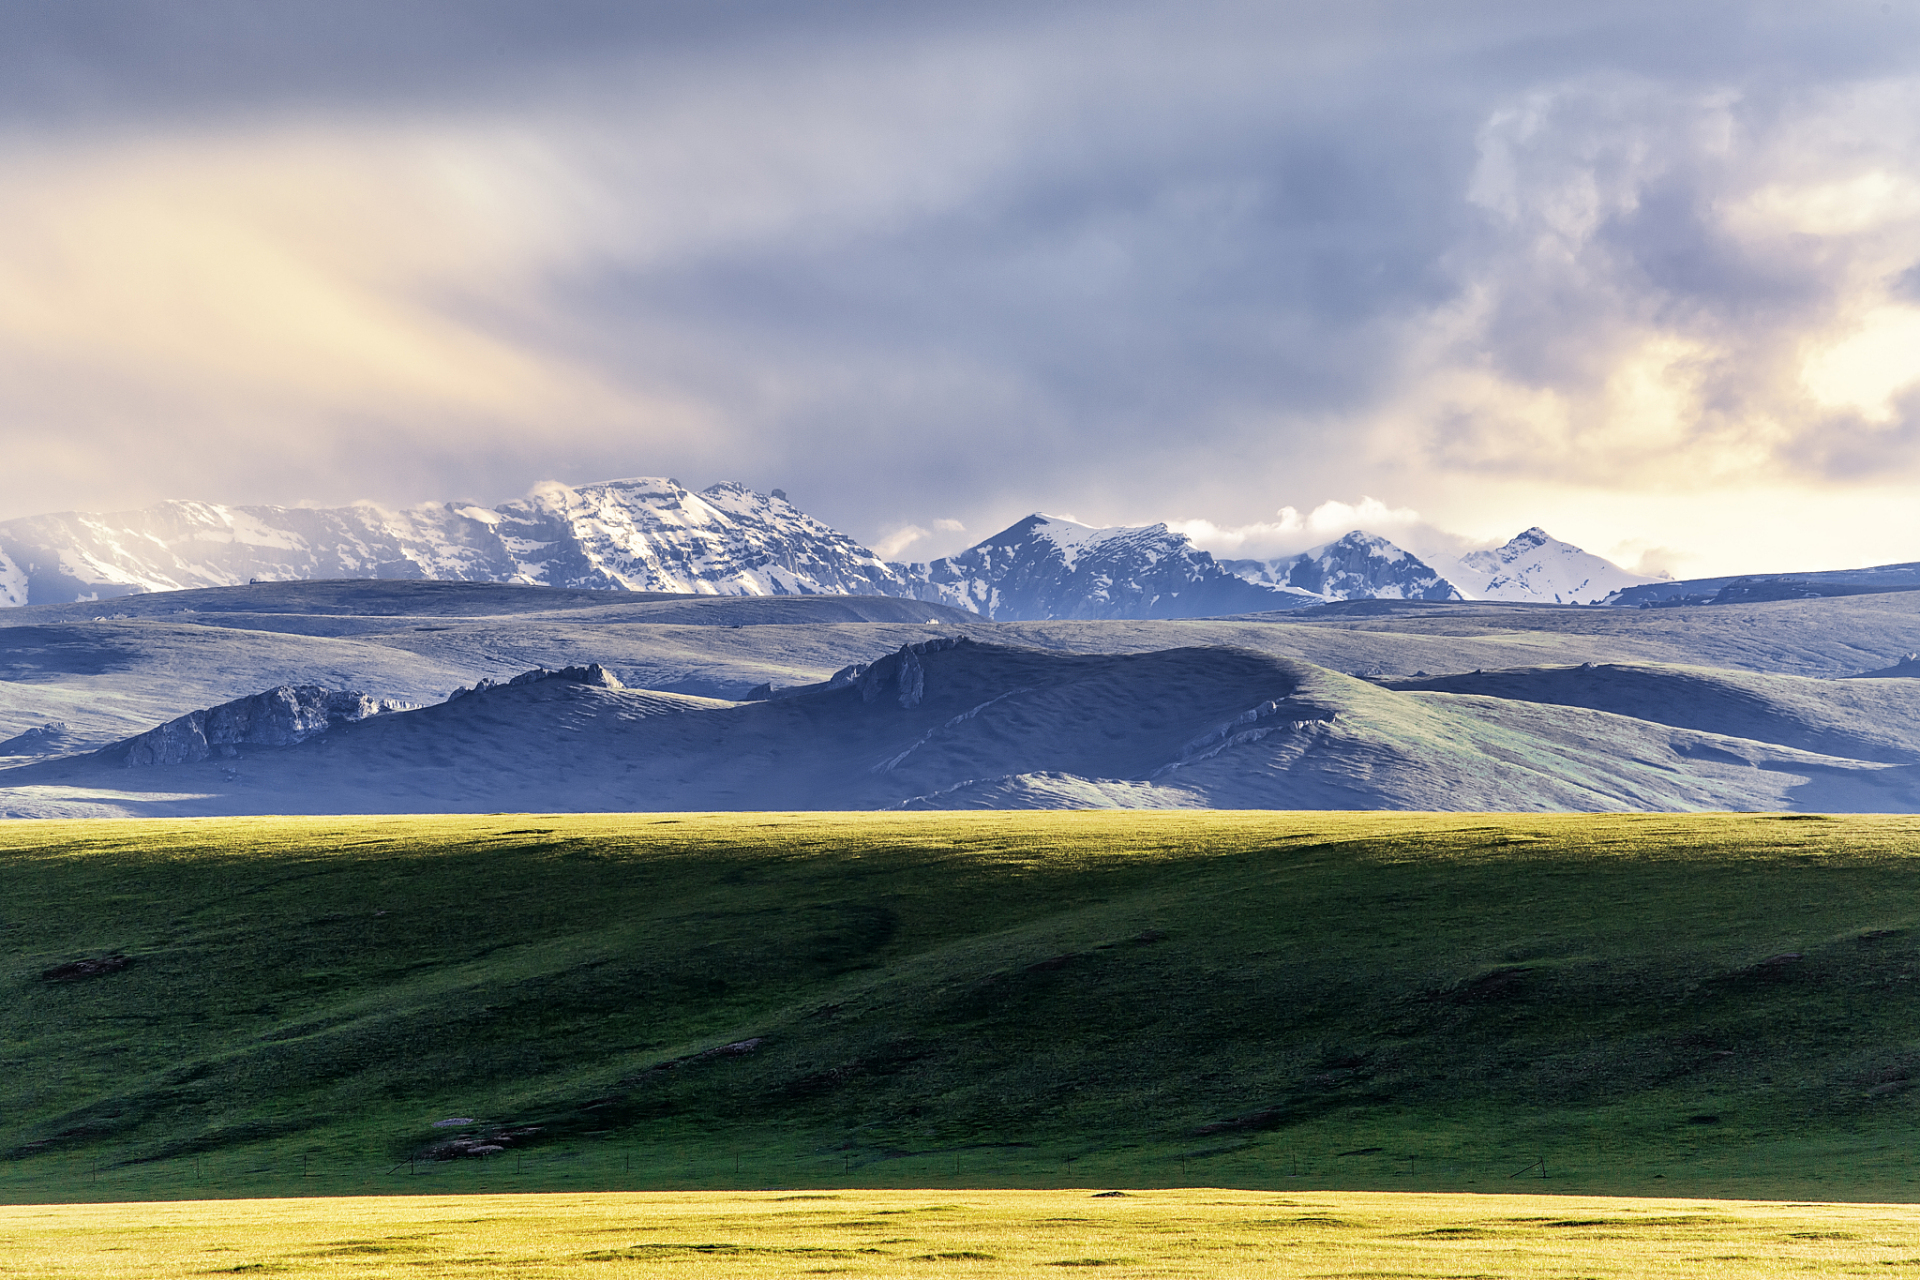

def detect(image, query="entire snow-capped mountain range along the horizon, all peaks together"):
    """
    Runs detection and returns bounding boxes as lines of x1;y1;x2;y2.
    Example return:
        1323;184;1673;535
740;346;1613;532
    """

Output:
0;478;1651;620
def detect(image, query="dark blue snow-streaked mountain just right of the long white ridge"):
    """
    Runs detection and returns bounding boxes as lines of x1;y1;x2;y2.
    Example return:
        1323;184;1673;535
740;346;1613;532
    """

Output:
908;514;1319;622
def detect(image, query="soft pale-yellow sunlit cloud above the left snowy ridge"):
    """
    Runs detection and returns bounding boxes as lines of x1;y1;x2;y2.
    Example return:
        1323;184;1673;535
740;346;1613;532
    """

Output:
0;130;701;503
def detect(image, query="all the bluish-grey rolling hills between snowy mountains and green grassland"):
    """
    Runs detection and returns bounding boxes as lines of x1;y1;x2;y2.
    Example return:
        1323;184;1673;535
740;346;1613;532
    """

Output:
11;581;1920;818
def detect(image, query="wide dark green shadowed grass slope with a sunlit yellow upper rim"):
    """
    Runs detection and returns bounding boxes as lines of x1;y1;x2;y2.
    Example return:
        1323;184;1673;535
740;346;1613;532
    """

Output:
0;812;1920;1203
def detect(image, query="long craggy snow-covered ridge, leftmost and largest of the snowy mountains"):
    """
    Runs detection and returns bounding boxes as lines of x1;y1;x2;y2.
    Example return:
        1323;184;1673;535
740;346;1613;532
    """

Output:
0;478;914;604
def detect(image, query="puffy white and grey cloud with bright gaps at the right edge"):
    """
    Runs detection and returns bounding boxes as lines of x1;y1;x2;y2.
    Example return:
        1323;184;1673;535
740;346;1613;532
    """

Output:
1377;77;1920;489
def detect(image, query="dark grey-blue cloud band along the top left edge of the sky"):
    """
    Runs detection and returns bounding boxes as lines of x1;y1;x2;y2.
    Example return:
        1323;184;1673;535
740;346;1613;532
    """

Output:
0;0;1023;125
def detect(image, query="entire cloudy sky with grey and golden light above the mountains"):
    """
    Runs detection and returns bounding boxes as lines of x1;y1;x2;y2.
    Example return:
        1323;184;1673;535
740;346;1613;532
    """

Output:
0;0;1920;576
